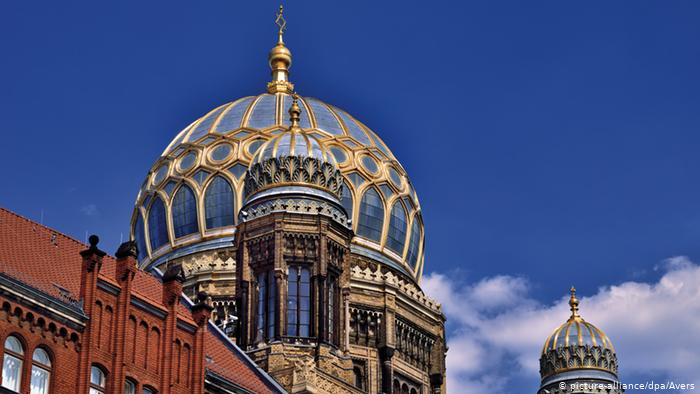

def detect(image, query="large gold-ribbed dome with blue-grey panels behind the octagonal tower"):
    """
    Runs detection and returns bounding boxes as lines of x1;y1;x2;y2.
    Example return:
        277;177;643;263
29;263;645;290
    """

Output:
131;25;424;281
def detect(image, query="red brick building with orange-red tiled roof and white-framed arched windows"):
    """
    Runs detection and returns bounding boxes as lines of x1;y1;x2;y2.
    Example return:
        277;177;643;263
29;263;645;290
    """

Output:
0;209;283;394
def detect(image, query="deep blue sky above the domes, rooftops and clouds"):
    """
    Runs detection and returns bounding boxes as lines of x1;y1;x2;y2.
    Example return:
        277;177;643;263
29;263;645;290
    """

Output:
0;0;700;390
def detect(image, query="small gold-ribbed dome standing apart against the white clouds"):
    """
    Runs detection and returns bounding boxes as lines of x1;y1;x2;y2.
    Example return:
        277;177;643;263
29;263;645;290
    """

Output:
540;287;617;382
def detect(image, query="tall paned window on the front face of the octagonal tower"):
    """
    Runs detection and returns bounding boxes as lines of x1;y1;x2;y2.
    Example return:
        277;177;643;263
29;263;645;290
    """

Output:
287;266;311;337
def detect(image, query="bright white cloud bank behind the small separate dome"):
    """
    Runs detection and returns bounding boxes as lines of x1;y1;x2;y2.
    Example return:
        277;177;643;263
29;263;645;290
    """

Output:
423;257;700;394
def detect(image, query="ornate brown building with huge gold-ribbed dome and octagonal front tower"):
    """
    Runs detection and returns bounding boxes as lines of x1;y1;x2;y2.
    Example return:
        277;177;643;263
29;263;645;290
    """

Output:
131;6;446;393
